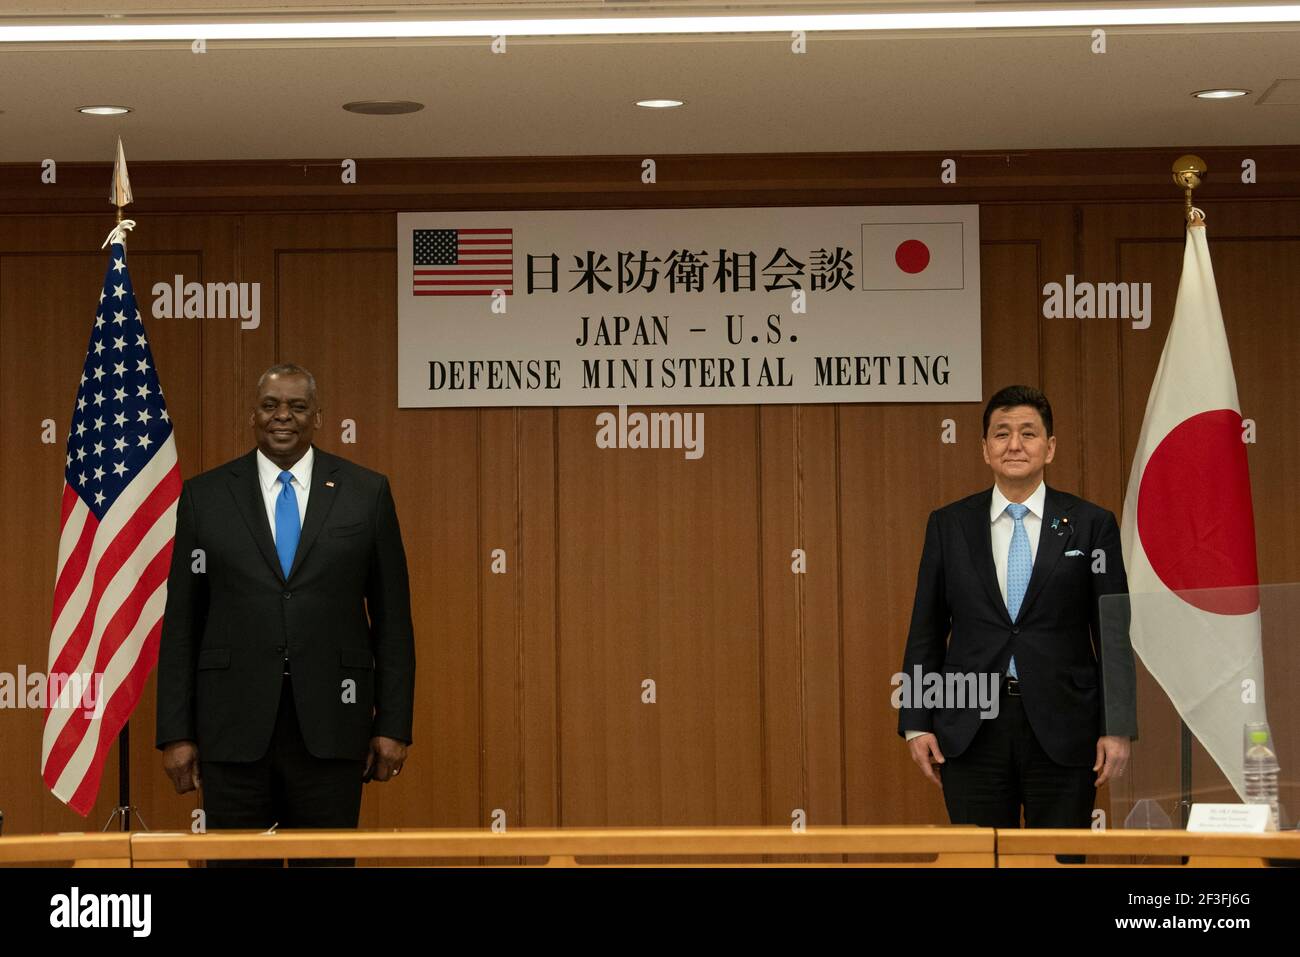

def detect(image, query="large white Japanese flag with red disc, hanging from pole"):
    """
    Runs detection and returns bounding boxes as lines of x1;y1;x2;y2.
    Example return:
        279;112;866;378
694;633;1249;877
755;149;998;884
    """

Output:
1121;222;1265;800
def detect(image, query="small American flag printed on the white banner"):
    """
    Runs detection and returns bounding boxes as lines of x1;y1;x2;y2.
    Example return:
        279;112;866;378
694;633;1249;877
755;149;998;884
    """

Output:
411;229;515;295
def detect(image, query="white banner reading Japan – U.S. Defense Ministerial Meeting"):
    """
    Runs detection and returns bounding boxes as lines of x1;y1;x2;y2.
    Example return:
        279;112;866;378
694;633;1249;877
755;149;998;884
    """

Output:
398;205;983;408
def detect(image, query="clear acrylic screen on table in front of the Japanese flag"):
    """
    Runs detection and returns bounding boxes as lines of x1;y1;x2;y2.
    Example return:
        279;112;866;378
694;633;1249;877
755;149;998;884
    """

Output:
1099;583;1300;831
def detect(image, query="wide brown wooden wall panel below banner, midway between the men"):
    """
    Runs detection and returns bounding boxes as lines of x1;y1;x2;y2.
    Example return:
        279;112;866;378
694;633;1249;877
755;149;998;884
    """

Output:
556;407;761;826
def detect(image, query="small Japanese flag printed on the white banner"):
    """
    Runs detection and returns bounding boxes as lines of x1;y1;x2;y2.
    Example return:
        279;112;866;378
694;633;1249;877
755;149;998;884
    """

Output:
862;222;966;291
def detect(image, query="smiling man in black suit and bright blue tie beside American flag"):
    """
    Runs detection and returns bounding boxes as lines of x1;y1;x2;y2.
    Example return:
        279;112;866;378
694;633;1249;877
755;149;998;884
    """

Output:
157;363;415;828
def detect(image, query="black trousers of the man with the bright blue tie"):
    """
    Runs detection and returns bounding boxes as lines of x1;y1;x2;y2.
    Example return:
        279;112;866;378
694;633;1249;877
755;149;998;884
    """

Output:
199;675;365;867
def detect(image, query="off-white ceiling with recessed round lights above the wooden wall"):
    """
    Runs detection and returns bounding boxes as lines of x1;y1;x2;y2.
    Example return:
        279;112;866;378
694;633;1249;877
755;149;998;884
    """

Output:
0;0;1300;163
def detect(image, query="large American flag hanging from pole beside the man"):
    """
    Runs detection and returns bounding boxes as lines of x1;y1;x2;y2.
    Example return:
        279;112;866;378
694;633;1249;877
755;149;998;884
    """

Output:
40;242;181;817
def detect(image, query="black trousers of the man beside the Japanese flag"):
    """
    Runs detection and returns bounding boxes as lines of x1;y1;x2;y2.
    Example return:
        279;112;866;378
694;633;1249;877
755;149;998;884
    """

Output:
939;687;1097;837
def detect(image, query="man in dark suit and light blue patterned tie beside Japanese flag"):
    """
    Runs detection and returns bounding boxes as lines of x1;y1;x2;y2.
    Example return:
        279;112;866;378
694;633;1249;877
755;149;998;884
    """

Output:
898;386;1138;827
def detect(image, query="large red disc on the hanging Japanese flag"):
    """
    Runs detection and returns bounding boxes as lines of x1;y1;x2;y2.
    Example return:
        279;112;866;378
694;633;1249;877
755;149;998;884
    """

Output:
1138;408;1260;615
